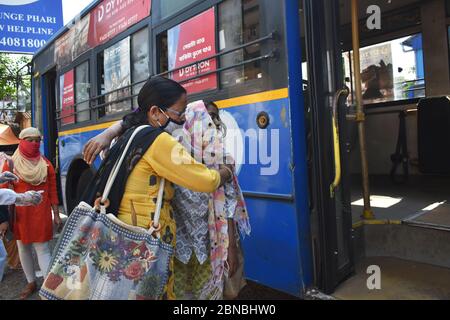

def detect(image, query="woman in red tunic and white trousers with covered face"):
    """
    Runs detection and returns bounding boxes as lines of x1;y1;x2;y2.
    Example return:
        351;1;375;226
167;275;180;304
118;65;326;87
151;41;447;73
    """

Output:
3;128;61;299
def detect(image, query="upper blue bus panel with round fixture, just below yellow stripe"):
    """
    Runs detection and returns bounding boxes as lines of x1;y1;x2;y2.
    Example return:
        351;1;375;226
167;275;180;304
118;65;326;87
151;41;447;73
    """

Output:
222;98;293;198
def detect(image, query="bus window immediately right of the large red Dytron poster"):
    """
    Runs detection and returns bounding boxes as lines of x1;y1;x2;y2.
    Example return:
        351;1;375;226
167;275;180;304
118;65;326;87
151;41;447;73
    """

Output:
218;0;262;87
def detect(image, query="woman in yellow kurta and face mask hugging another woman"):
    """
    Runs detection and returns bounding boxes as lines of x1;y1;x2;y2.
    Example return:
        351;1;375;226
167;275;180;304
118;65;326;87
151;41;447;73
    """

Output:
84;77;232;300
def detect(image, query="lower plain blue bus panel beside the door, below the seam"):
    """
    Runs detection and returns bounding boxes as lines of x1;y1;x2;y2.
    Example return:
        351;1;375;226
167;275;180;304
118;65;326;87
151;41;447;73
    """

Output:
243;198;303;296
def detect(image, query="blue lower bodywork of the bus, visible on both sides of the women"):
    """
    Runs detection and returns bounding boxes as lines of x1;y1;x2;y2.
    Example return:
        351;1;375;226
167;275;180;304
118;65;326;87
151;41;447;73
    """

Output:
59;93;303;296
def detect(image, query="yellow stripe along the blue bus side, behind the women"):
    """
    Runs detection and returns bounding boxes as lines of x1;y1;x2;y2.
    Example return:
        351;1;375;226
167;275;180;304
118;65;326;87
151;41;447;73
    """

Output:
59;88;289;137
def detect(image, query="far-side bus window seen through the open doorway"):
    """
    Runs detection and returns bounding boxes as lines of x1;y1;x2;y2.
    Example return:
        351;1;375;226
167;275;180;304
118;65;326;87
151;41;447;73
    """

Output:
343;34;425;104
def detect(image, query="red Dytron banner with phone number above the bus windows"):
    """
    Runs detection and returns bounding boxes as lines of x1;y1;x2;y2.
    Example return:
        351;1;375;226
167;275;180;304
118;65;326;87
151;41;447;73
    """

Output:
89;0;152;47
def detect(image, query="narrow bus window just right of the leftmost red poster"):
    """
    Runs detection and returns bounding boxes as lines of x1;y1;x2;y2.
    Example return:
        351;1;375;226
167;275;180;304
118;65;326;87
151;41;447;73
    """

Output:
75;61;91;122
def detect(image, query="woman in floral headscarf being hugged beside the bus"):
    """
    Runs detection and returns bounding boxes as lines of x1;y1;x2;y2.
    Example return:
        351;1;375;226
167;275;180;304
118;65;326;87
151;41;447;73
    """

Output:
85;101;250;300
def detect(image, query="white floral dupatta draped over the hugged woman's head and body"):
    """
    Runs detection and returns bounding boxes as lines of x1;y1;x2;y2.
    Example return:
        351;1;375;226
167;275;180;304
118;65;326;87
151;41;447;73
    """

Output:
178;101;251;299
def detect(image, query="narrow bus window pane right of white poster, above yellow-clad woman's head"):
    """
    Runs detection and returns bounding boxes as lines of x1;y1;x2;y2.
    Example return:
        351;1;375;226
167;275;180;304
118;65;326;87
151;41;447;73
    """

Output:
131;28;150;108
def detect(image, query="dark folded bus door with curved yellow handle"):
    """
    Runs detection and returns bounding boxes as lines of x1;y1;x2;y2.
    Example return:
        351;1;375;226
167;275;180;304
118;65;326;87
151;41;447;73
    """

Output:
301;0;354;294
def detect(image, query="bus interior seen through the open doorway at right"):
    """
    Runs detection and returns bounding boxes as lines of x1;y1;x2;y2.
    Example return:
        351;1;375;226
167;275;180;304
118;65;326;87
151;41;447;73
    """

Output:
300;0;450;299
